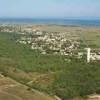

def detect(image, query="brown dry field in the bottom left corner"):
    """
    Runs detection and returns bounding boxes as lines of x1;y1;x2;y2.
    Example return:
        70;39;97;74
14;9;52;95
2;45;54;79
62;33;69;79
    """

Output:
0;75;54;100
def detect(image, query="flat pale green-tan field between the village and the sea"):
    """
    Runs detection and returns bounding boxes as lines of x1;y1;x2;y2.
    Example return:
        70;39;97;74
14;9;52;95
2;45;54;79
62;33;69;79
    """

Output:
33;25;100;47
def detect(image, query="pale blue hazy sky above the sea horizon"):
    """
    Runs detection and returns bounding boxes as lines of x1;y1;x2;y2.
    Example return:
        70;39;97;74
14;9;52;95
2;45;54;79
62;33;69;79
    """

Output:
0;0;100;19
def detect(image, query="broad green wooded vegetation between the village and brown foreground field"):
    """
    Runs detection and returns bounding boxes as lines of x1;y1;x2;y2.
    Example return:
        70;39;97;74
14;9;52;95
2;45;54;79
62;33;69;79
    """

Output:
0;33;100;100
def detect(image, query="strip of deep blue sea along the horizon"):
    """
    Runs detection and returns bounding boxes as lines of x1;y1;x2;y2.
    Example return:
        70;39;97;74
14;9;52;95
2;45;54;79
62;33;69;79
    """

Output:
0;18;100;26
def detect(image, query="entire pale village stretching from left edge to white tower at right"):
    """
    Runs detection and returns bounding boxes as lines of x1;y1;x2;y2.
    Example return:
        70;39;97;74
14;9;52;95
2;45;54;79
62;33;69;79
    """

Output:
0;24;100;62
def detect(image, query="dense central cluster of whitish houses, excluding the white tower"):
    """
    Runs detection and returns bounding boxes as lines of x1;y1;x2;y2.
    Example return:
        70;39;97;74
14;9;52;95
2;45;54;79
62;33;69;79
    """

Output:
18;30;80;55
